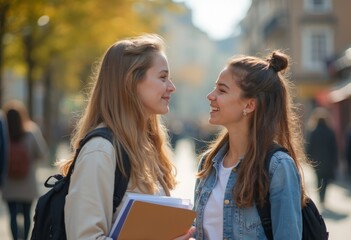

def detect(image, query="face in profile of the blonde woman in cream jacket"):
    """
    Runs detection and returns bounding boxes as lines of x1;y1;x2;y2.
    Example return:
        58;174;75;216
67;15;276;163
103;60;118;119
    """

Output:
137;53;176;115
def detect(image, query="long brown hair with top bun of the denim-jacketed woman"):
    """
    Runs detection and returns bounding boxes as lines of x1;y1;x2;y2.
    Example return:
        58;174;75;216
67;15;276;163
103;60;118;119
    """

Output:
198;51;307;207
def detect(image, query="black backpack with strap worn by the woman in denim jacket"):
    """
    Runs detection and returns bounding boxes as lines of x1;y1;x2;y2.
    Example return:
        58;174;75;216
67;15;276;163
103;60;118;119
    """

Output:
256;144;329;240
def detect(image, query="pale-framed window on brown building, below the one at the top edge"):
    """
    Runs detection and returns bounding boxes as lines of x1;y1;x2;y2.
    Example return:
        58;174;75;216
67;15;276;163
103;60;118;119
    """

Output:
301;27;333;71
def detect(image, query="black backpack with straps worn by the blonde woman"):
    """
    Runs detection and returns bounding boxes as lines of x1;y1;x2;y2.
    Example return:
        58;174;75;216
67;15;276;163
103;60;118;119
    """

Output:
31;128;130;240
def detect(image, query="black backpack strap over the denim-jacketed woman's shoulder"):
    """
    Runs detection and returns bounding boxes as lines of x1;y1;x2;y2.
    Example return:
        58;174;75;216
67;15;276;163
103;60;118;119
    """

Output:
256;143;288;240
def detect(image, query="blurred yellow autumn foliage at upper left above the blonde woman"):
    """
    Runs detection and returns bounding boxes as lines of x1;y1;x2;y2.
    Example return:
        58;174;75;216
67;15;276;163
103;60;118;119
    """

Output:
2;0;172;91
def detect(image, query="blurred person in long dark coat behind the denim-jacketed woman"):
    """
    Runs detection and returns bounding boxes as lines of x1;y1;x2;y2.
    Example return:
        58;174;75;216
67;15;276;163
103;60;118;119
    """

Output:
306;107;338;207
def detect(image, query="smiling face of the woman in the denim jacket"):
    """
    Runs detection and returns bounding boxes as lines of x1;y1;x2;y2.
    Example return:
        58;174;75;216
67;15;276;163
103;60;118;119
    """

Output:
207;68;248;128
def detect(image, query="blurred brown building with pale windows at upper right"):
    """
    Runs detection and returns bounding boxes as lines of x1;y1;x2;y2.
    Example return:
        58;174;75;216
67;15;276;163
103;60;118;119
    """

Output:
239;0;351;168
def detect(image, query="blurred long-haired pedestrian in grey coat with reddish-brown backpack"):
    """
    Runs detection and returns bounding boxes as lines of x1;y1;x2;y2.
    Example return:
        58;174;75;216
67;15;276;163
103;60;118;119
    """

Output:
2;100;47;240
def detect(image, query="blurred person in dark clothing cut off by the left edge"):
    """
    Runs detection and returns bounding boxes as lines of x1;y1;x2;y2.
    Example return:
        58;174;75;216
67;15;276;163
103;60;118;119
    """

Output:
0;109;9;190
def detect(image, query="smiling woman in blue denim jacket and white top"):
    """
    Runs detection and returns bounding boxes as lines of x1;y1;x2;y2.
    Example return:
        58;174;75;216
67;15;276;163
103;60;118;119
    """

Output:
194;51;307;240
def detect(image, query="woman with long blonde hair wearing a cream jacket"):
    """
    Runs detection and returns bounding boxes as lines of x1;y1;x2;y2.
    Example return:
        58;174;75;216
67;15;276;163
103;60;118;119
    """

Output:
59;35;195;240
